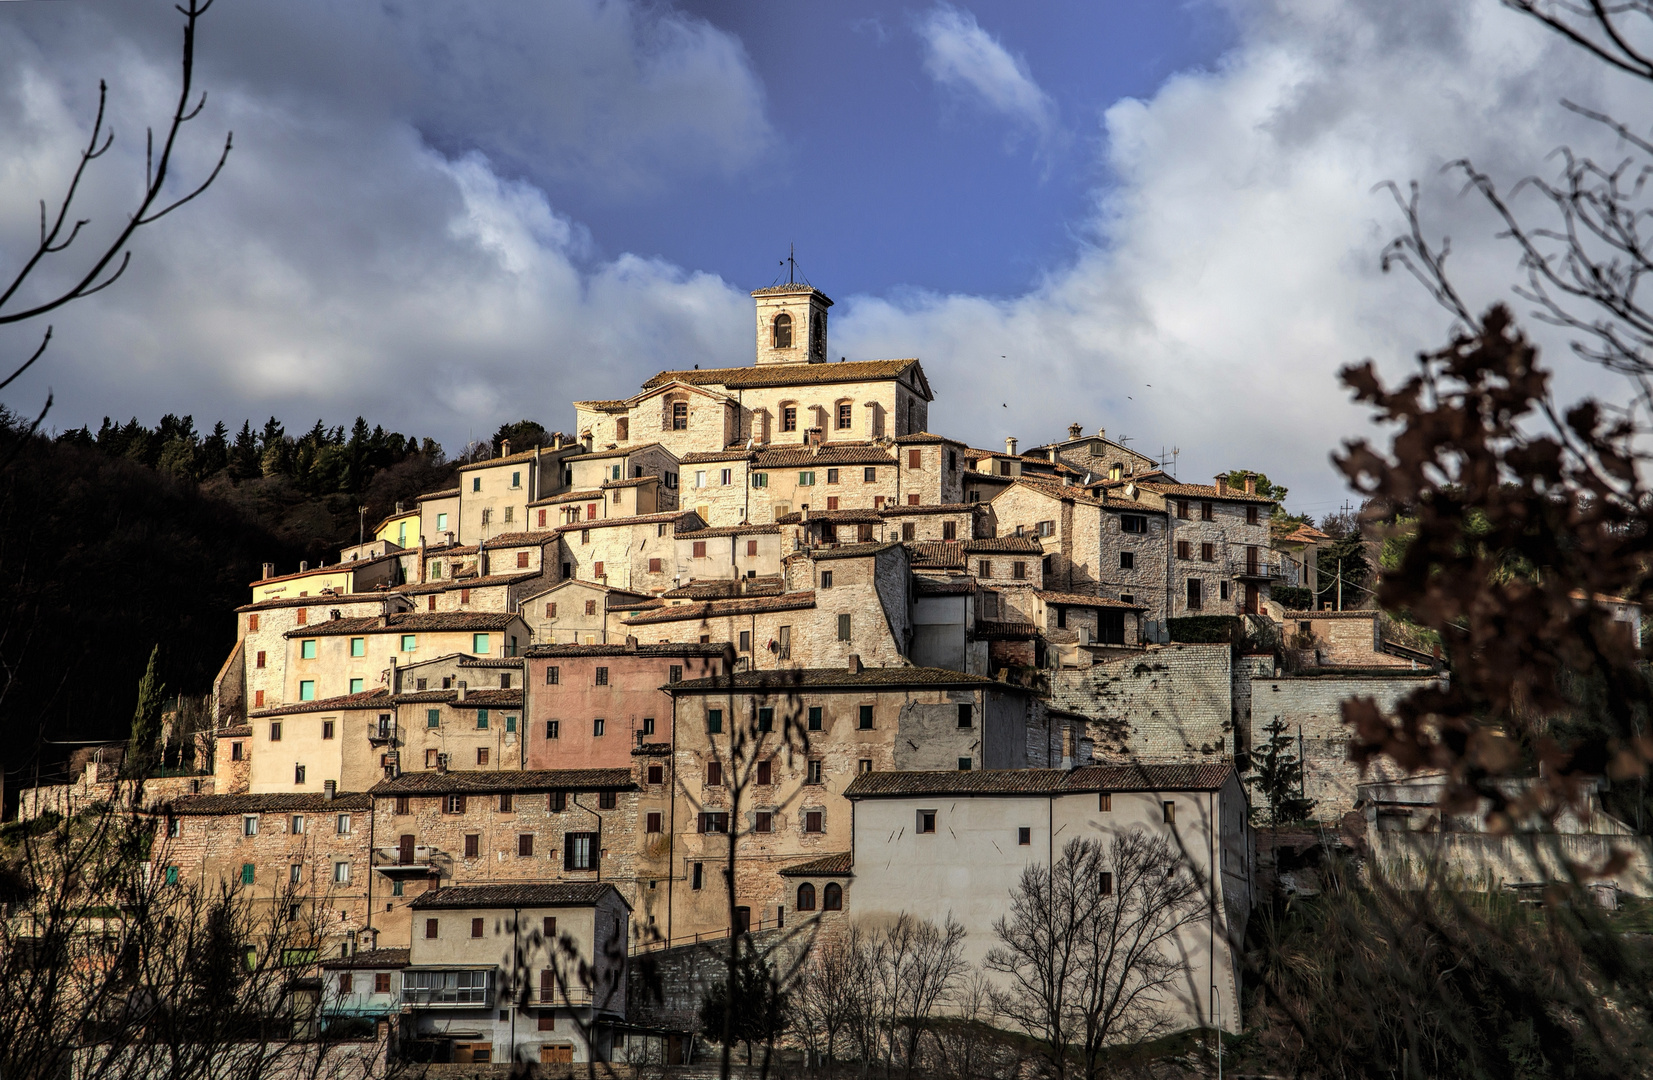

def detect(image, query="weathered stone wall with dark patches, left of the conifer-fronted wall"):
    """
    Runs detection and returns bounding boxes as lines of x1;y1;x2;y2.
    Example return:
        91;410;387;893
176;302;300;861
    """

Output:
1051;645;1235;761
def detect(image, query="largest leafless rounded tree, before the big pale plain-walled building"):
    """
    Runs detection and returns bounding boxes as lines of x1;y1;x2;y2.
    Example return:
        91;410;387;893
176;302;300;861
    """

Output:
987;832;1205;1080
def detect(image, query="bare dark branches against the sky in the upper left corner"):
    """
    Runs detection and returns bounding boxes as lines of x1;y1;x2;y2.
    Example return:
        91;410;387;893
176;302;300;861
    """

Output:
0;0;231;446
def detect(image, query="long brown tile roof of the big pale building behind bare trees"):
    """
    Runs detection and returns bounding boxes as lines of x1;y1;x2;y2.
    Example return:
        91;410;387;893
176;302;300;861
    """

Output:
843;762;1233;799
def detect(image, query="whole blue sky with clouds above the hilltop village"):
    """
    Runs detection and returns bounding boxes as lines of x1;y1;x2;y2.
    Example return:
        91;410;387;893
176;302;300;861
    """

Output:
0;0;1643;514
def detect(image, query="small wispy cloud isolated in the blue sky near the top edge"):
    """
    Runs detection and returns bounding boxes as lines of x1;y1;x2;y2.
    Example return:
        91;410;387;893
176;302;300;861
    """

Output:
917;3;1058;151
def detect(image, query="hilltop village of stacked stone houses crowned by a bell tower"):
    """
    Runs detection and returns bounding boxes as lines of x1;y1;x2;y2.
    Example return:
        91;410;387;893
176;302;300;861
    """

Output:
23;284;1520;1062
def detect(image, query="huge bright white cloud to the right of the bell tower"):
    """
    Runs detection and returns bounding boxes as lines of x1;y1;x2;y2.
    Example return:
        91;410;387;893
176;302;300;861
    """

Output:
835;0;1645;513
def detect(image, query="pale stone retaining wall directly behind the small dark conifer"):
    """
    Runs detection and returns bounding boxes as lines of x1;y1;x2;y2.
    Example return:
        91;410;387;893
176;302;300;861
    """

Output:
1251;675;1435;820
